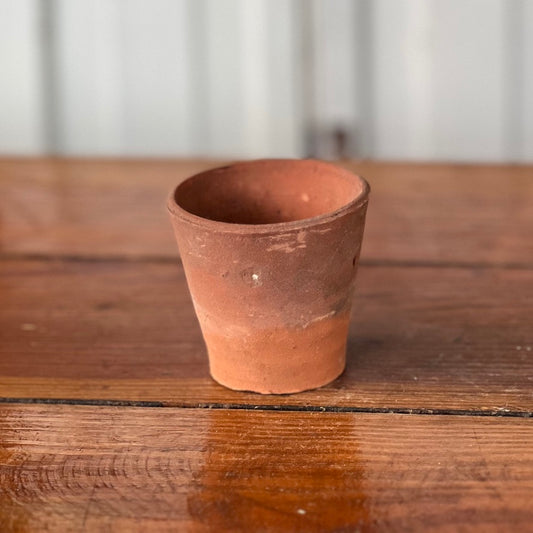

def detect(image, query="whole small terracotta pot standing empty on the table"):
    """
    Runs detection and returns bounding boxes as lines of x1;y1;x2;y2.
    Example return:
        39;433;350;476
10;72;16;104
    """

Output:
168;160;370;394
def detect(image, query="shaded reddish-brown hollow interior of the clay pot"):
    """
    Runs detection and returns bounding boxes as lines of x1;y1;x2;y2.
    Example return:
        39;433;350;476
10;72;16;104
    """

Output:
174;160;364;224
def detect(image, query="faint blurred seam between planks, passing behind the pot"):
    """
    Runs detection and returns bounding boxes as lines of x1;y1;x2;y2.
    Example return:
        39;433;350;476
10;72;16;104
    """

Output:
0;252;533;270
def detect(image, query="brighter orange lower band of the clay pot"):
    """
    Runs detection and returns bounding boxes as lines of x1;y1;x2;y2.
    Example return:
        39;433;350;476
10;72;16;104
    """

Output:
204;314;349;394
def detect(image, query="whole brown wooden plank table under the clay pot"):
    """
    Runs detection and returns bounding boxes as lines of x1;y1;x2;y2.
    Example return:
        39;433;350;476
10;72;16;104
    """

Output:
0;159;533;532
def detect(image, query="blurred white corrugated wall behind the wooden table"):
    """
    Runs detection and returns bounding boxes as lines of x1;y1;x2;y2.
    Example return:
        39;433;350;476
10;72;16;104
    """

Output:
0;0;533;162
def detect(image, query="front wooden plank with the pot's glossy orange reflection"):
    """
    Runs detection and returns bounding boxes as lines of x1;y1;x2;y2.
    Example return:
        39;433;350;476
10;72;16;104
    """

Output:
0;405;533;532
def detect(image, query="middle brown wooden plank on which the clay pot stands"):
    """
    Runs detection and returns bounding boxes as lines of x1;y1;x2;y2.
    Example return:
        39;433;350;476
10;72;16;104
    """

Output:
0;260;533;414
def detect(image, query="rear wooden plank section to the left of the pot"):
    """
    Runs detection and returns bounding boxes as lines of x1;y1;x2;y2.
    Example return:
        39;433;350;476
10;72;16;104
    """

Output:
0;159;220;257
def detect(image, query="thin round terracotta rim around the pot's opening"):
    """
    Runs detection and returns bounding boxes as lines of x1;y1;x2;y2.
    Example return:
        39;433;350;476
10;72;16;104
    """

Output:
167;158;370;234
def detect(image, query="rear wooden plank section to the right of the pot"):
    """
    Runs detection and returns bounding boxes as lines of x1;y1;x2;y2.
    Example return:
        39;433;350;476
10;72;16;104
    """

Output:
353;163;533;267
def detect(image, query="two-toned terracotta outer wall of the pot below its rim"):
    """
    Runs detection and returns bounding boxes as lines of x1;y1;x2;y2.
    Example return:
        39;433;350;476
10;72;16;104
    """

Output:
171;201;367;394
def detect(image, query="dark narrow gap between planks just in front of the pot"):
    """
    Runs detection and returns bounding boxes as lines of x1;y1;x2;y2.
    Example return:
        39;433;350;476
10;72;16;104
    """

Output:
0;397;533;418
